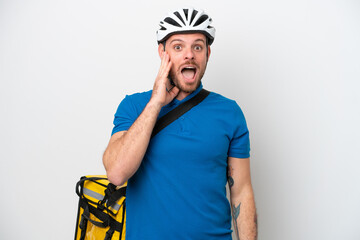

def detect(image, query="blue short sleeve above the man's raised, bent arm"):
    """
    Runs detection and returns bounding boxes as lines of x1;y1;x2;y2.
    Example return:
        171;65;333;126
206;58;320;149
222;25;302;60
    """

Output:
111;96;137;135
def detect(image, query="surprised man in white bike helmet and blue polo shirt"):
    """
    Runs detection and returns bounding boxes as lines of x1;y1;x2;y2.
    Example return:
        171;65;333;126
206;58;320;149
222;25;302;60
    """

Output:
103;8;257;240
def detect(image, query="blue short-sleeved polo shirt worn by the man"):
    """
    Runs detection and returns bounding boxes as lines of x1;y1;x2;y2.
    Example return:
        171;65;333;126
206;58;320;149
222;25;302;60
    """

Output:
112;85;250;240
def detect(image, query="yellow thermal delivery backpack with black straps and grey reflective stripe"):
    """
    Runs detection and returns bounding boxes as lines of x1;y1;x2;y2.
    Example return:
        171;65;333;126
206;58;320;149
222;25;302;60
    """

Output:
75;175;126;240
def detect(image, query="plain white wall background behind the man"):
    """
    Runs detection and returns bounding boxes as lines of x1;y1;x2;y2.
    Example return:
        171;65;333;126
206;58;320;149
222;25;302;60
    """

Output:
0;0;360;240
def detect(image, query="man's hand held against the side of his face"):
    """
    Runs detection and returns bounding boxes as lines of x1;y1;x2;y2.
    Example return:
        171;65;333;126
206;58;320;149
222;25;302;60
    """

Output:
150;51;179;107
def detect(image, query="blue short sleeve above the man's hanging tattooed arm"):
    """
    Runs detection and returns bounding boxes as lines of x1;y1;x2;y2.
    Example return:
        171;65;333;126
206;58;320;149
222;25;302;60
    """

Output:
228;102;250;158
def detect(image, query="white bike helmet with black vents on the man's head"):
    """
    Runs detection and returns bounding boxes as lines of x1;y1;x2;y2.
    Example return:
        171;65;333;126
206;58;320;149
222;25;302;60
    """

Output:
156;8;215;45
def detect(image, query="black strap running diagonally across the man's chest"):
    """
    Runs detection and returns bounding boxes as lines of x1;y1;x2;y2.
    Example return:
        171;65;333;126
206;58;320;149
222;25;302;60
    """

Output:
151;89;210;137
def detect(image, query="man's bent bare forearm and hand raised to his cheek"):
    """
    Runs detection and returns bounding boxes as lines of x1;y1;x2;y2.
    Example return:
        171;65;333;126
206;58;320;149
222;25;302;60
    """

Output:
103;53;179;186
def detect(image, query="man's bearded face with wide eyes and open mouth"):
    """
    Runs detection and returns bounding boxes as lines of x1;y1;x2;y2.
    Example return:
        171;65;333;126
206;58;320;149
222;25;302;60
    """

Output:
161;33;210;93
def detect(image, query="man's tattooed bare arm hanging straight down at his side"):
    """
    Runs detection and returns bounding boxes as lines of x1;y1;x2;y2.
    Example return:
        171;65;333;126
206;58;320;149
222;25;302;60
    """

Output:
228;157;257;240
